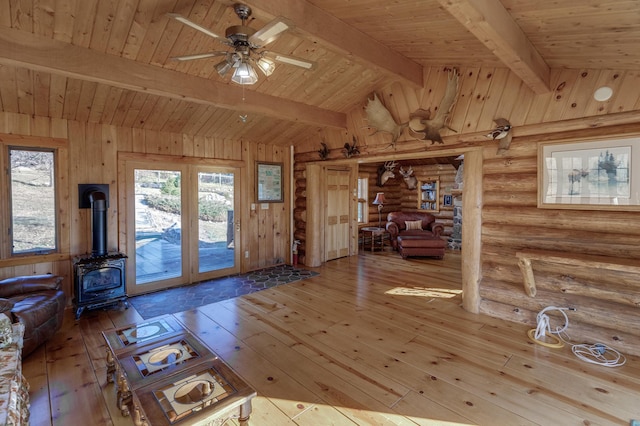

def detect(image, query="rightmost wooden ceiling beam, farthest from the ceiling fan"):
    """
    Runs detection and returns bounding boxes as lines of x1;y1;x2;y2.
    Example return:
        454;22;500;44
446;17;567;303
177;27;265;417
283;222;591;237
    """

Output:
438;0;551;95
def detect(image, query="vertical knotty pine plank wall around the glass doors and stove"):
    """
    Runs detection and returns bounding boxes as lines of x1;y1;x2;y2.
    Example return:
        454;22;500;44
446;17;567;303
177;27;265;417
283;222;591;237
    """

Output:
0;113;291;303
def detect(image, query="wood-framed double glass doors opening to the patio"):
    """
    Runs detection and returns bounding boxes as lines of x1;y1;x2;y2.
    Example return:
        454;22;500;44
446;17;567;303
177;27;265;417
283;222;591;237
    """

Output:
126;161;240;295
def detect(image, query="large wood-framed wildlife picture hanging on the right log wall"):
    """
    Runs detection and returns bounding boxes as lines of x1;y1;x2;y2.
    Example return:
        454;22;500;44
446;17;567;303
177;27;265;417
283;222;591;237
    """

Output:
538;137;640;210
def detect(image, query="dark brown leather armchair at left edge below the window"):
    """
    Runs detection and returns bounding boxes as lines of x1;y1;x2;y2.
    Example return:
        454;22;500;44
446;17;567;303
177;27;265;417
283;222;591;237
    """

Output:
0;275;66;357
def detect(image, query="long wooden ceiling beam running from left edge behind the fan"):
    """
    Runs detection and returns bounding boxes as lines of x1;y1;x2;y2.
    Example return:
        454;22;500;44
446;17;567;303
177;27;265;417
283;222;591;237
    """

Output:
0;26;347;129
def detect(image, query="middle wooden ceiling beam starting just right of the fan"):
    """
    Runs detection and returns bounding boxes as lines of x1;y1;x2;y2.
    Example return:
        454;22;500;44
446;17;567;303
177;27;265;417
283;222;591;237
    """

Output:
247;0;424;87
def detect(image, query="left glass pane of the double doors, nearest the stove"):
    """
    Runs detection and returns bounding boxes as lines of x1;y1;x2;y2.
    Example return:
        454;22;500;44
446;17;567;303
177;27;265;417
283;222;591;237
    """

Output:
134;169;183;284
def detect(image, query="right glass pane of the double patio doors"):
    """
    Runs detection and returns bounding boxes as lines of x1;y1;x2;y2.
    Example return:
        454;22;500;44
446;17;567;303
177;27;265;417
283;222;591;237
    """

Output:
197;171;236;274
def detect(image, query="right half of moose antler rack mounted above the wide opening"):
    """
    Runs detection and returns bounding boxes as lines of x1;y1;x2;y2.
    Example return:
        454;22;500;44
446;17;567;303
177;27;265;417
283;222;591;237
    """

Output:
409;69;459;145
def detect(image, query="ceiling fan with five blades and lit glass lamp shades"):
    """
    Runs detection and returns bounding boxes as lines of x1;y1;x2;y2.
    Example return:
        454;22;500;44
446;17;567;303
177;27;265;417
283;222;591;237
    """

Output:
167;3;316;84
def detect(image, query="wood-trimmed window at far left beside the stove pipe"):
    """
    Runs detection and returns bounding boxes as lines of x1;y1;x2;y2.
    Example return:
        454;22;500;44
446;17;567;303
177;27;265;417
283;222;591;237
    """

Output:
0;135;69;265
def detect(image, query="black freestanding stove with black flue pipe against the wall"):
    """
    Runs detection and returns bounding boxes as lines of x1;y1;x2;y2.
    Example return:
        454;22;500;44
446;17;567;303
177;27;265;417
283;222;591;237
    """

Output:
73;188;129;319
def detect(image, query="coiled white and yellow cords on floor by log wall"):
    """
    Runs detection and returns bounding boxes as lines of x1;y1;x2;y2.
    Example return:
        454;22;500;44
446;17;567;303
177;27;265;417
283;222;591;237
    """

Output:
528;306;627;367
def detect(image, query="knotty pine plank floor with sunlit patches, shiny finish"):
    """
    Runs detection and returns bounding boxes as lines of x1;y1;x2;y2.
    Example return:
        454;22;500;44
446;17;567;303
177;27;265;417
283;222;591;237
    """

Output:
23;252;640;426
